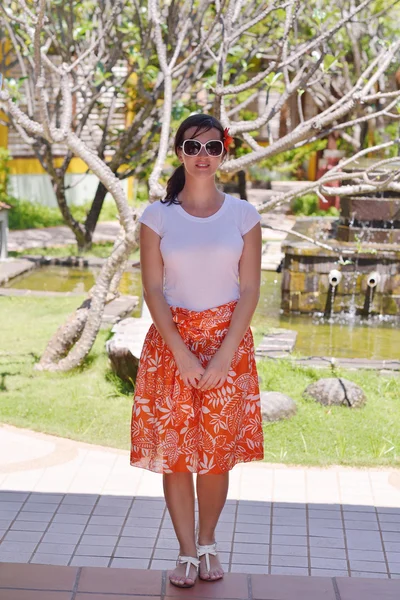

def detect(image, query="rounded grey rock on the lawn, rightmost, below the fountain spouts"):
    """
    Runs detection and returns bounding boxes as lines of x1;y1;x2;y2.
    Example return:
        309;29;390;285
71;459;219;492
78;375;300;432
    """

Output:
303;377;367;408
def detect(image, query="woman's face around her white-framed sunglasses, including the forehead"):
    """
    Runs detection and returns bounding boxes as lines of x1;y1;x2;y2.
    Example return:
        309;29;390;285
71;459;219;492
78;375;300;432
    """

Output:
177;127;224;179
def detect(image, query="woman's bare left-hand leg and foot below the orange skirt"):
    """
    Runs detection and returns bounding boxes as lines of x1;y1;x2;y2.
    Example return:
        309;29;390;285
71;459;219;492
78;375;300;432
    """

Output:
163;473;197;584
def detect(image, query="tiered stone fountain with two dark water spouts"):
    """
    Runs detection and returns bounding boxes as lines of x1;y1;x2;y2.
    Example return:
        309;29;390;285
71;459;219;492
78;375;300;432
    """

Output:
281;184;400;317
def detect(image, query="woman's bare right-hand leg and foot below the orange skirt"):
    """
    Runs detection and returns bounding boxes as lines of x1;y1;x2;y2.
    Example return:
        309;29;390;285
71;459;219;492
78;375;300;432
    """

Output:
196;473;229;579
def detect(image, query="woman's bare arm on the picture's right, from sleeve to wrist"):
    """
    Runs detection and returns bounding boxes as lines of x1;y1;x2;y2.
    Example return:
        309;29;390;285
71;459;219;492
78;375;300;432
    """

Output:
218;223;262;358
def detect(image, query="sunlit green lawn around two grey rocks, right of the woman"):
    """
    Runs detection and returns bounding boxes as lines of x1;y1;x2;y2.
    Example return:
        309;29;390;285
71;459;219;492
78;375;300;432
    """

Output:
258;360;400;466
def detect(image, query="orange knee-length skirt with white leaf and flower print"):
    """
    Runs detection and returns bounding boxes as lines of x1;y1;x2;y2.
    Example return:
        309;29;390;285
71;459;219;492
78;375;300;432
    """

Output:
130;300;264;474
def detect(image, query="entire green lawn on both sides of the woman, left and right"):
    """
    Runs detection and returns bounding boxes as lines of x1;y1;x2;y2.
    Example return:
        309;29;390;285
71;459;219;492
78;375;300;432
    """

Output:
0;297;400;466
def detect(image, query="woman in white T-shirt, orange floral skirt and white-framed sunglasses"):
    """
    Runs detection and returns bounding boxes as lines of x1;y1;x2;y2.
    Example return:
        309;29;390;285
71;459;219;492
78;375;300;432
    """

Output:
131;114;264;587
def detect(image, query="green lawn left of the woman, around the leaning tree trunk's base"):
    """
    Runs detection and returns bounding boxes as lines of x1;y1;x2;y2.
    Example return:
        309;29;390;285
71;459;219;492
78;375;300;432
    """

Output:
0;296;132;448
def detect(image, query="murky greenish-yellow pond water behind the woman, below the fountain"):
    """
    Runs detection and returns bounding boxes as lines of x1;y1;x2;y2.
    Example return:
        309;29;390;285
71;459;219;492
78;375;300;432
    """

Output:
5;266;400;359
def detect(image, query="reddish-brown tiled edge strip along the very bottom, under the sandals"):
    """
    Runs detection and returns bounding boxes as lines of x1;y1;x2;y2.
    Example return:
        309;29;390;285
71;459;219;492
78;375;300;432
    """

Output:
0;564;400;600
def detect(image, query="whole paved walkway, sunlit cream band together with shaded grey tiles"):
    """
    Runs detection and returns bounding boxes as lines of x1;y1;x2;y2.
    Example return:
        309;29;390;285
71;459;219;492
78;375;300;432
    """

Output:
0;425;400;580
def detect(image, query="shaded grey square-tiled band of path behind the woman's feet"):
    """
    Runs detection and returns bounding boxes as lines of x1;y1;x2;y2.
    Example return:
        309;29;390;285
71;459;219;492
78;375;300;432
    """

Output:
0;490;400;579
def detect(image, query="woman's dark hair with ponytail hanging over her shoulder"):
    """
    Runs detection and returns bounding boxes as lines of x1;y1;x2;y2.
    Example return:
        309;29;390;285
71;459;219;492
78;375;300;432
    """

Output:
160;113;226;206
